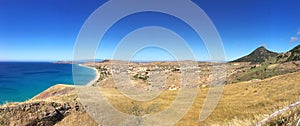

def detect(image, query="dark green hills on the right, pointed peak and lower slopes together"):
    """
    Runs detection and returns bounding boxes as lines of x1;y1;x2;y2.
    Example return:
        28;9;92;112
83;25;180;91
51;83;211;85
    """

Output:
232;45;300;83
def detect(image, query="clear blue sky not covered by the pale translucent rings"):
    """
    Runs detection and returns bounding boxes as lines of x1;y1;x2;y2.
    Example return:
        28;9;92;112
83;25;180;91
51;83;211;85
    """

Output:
0;0;300;61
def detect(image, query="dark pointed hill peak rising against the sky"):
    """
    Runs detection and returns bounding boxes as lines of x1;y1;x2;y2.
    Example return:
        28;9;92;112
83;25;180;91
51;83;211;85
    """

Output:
232;46;278;63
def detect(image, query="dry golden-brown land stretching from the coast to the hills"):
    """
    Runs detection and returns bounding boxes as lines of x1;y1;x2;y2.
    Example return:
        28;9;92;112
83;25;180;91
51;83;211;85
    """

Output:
0;46;300;126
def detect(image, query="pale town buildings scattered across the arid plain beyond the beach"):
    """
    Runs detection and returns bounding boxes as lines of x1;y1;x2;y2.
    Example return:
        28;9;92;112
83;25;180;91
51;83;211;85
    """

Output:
89;62;250;90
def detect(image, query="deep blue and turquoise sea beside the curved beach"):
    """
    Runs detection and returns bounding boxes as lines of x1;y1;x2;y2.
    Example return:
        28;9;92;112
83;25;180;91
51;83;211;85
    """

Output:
0;62;95;104
